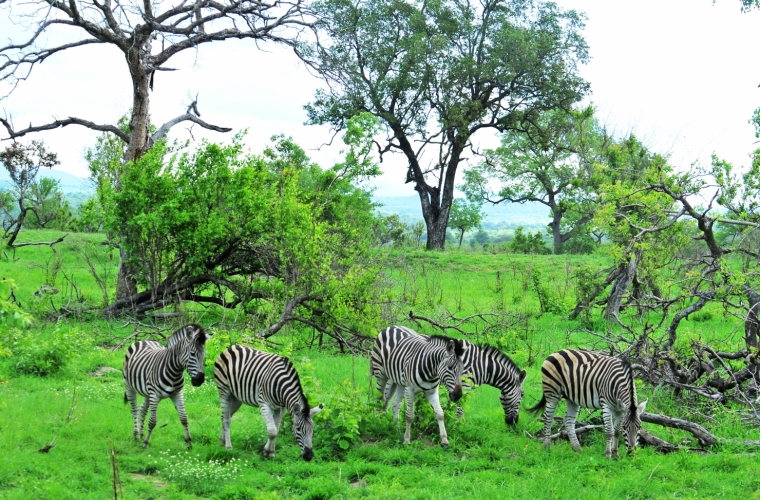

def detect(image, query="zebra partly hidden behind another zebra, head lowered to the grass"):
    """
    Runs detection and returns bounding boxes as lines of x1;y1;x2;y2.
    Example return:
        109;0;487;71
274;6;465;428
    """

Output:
376;328;526;425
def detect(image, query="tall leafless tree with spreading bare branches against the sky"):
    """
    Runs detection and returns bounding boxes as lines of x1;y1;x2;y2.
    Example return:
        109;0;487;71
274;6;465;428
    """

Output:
0;0;310;298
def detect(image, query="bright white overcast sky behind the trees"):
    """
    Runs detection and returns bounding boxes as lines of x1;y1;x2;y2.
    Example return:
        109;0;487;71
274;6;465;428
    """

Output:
0;0;760;196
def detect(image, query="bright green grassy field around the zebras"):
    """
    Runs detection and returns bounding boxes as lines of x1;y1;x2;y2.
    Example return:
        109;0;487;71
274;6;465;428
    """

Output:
0;232;760;499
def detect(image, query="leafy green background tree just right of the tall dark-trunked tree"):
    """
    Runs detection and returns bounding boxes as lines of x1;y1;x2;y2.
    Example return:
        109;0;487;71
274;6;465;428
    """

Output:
463;107;606;254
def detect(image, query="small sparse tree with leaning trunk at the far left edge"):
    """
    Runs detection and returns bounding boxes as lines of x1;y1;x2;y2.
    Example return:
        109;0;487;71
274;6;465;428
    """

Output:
0;141;59;248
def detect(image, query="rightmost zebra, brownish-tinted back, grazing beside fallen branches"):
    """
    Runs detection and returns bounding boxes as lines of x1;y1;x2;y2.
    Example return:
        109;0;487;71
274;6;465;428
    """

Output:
529;349;647;458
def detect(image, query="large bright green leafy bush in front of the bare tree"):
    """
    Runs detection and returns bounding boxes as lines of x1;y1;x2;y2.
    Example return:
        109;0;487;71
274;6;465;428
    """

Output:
103;136;386;343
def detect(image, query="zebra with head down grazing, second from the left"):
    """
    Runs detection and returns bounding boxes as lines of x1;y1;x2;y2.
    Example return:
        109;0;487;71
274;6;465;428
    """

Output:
214;345;324;462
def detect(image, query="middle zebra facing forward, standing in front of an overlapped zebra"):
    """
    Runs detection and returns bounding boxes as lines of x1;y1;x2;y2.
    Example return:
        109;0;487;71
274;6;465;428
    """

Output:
370;326;465;448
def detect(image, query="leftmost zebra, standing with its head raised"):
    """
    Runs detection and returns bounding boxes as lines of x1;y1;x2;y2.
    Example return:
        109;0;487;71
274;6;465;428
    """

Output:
123;324;208;448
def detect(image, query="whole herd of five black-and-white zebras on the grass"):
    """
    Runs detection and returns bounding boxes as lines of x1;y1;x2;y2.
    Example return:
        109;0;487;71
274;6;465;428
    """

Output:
123;324;646;461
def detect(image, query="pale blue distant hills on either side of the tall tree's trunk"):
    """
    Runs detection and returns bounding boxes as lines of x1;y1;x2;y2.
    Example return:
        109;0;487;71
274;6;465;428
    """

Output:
372;195;549;229
